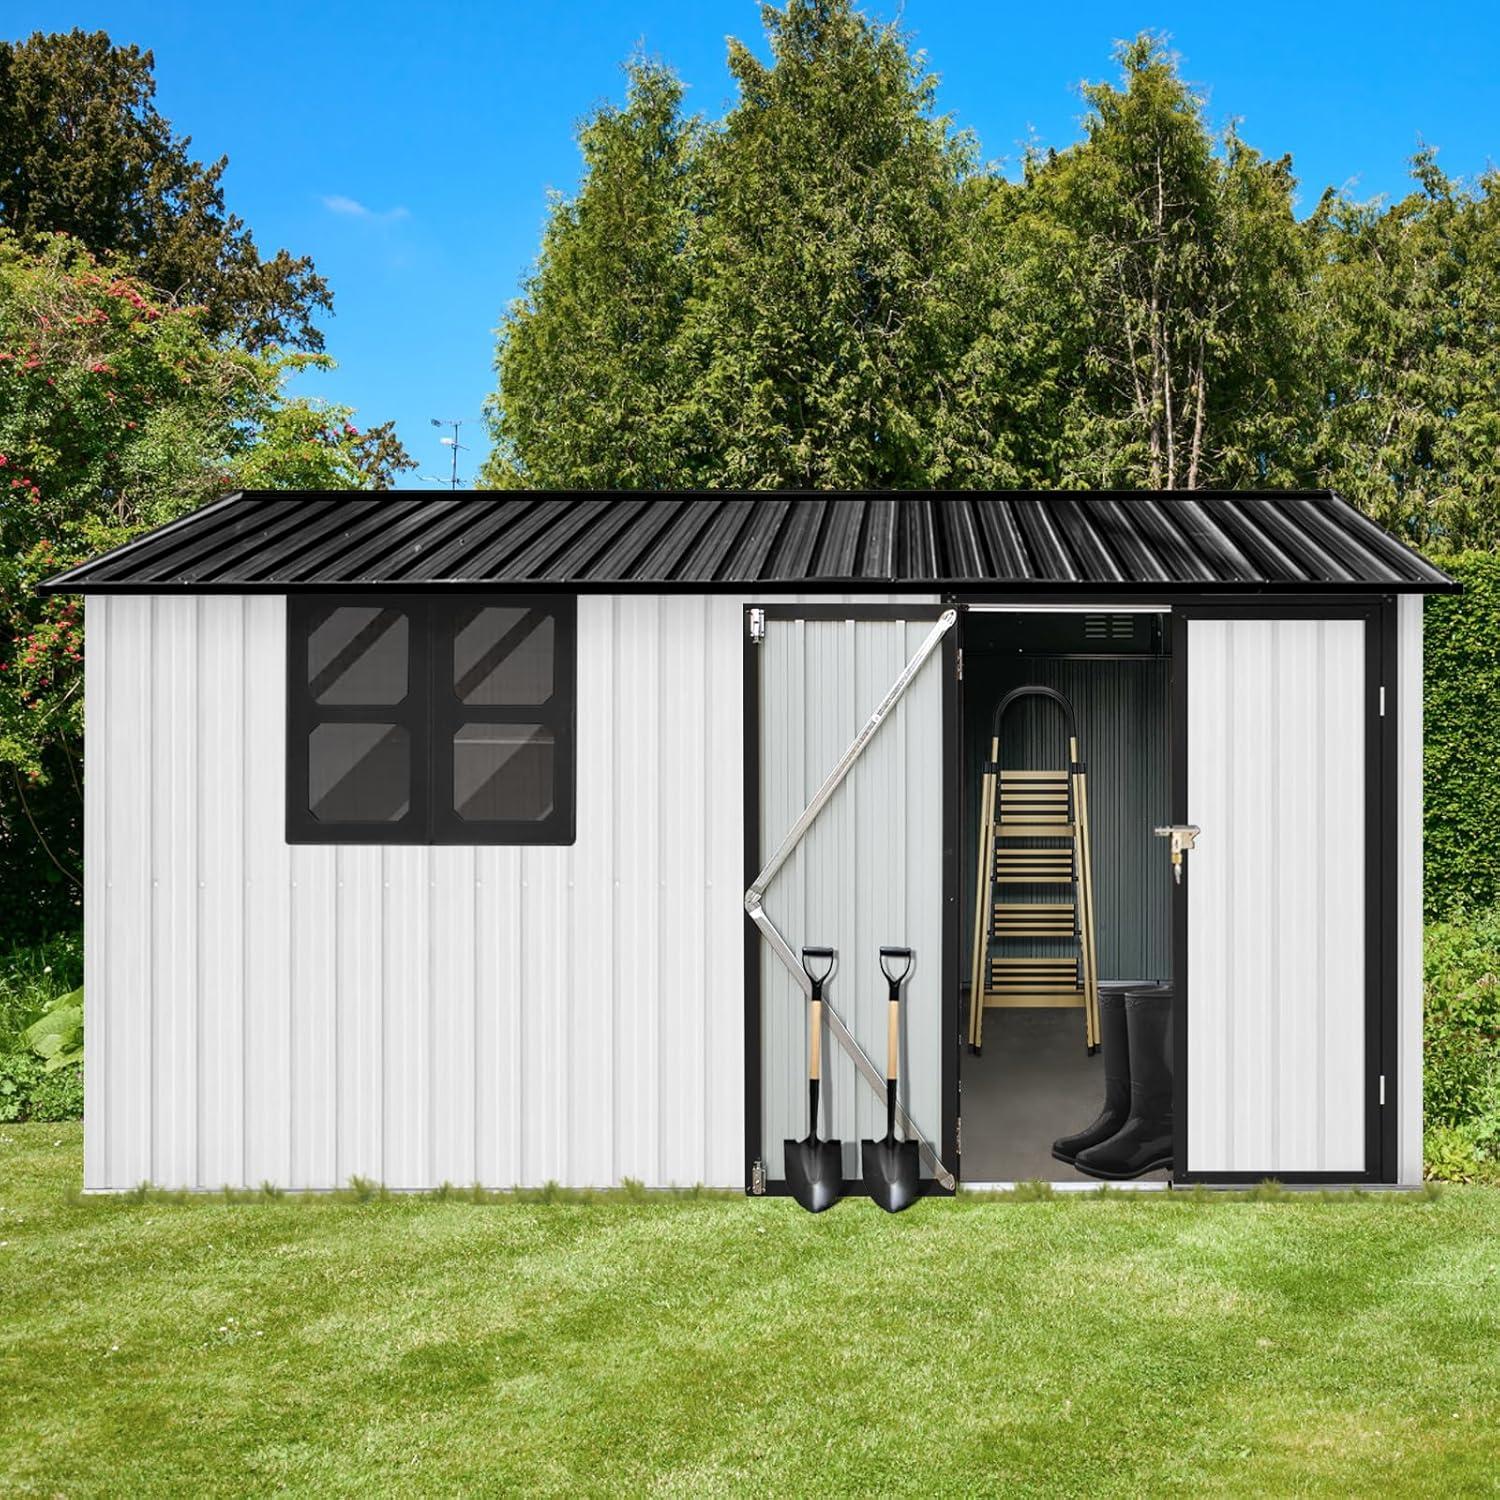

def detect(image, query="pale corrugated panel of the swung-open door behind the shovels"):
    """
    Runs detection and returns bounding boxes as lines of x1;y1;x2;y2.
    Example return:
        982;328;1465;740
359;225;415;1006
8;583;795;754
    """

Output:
747;606;957;1191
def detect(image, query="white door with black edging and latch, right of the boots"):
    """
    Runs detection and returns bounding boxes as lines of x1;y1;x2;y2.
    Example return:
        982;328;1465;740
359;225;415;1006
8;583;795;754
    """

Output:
1173;605;1383;1182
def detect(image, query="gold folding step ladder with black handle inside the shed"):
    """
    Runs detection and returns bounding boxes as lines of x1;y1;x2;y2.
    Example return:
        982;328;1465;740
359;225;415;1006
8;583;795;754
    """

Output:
969;687;1100;1053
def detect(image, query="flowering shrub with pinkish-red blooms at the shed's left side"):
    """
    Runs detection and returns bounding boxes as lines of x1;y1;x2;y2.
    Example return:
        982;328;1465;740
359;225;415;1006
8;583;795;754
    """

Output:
0;231;408;786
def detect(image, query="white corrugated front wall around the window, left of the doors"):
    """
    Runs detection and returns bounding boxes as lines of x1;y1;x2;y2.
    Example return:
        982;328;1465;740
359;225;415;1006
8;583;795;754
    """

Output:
84;596;870;1190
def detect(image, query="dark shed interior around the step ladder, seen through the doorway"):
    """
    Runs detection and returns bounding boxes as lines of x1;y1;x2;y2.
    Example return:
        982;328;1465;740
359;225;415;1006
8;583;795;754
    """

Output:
960;609;1172;1184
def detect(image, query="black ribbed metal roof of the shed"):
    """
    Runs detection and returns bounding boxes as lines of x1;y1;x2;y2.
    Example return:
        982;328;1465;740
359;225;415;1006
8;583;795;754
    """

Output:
42;491;1455;593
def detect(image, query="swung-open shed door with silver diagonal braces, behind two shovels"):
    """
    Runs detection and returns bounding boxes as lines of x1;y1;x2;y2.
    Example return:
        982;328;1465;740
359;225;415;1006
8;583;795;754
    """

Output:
746;605;957;1193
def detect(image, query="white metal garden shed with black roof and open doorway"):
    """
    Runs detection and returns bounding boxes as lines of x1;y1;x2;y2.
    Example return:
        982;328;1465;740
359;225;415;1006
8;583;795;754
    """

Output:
45;492;1454;1194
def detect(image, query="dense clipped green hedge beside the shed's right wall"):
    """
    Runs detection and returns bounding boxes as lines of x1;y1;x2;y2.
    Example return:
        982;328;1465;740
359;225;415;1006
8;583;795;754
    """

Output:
1422;552;1500;918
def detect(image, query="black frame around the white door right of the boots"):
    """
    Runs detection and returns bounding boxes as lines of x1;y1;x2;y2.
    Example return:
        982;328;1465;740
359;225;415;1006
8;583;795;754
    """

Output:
1172;596;1400;1185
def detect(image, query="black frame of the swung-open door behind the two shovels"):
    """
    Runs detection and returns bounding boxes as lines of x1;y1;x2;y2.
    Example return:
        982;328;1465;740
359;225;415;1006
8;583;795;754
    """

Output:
743;602;963;1197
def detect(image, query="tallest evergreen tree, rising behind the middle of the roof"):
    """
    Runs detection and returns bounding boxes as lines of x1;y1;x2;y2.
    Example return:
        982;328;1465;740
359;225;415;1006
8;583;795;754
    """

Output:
684;0;978;489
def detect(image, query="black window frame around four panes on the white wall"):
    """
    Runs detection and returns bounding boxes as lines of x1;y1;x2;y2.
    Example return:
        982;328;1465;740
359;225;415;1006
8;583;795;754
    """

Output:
287;591;578;846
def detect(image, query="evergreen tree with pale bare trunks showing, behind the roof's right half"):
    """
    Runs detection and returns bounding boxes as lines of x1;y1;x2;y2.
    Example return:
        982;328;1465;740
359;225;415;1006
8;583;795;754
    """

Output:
1019;36;1307;489
